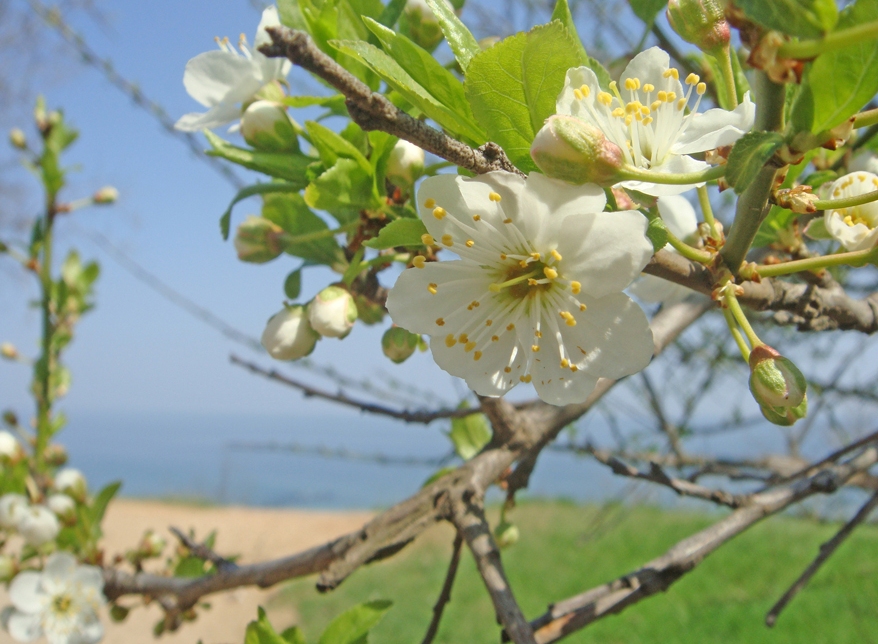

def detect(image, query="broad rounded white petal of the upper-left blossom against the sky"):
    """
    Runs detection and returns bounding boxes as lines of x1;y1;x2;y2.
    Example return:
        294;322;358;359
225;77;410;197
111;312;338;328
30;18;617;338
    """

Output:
183;51;262;107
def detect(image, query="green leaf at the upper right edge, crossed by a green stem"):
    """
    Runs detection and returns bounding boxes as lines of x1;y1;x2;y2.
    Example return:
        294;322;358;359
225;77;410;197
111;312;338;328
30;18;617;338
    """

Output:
792;0;878;134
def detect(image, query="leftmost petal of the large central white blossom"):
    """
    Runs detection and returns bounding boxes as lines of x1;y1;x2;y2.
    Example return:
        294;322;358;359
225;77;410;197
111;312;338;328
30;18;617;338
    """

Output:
387;260;491;337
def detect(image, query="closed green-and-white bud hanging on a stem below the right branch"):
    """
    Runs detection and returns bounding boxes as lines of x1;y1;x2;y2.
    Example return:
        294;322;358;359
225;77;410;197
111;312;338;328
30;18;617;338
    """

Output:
750;344;808;426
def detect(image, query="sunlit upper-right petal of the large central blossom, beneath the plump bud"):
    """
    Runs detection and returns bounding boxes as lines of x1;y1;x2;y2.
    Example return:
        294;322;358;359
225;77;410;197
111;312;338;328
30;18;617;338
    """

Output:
558;210;653;297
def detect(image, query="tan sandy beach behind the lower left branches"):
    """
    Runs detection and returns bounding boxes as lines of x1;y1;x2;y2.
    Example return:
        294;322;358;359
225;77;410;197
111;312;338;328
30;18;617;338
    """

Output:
0;499;372;644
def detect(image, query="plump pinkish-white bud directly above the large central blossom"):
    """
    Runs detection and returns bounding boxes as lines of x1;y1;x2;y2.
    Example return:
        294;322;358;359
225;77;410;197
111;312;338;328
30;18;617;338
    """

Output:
530;114;623;186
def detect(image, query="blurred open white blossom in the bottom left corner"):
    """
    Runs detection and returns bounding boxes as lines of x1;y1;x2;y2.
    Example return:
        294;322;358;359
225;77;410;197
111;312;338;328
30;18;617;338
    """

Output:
6;552;105;644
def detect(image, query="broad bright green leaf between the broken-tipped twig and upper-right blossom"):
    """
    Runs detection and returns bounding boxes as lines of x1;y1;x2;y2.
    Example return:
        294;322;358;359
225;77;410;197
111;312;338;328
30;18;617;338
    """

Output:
465;21;581;172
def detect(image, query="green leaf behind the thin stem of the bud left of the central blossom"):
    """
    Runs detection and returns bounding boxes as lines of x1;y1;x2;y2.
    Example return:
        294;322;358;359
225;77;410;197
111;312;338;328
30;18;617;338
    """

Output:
262;193;341;265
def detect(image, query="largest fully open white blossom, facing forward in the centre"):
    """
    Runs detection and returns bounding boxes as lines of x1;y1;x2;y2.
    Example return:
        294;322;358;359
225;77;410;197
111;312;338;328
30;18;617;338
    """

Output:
387;172;653;405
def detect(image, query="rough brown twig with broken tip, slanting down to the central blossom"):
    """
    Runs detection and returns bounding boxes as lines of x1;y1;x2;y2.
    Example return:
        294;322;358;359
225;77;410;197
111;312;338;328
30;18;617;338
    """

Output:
259;27;523;176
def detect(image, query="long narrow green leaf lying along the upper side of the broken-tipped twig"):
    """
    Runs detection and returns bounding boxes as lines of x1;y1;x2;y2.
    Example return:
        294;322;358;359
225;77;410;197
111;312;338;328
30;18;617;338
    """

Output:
333;40;487;144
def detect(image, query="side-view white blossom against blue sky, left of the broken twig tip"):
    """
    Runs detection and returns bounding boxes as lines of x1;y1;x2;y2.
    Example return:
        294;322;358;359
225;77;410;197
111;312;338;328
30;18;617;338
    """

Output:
174;7;291;132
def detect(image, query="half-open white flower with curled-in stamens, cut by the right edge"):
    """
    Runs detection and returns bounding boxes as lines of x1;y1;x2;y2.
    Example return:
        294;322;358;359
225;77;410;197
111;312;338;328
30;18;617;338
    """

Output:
823;172;878;251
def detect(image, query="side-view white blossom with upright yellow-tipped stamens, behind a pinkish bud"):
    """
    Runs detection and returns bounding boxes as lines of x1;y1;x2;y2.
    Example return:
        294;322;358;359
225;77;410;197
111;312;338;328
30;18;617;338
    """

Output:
555;47;756;196
